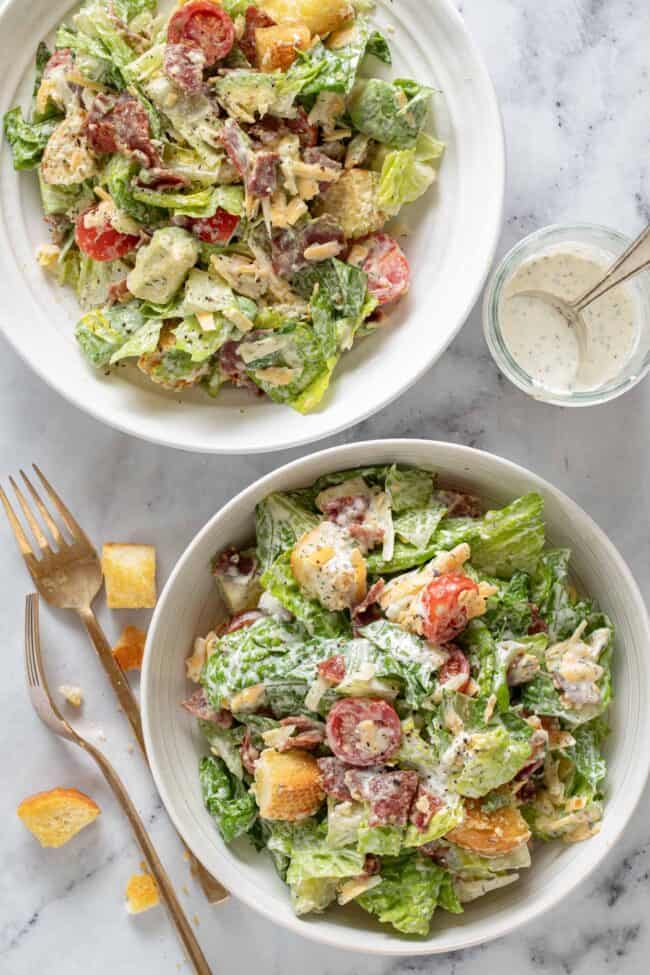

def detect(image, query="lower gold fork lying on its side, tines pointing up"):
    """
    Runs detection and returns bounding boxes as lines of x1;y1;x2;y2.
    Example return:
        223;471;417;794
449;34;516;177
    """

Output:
25;593;211;975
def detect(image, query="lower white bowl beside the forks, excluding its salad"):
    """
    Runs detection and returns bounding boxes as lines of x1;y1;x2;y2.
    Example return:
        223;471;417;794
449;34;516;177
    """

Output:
142;440;650;954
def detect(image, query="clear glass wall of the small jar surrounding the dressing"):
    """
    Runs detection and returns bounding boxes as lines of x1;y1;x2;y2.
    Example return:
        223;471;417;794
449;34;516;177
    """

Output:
483;224;650;406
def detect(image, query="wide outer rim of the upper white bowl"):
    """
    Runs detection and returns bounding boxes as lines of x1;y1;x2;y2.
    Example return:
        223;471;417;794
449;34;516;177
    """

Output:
0;0;506;455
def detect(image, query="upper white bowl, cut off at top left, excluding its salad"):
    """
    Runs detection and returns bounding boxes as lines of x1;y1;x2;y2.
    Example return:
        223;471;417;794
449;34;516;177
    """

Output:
0;0;505;454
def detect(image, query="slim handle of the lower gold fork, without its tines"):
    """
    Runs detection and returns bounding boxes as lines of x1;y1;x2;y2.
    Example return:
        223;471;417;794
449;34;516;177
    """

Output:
80;741;212;975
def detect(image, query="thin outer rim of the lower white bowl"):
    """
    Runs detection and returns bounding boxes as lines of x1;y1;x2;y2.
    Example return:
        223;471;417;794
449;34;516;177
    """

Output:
141;438;650;956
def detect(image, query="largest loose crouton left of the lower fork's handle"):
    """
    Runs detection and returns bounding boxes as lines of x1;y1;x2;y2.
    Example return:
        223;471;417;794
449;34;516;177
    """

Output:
16;788;101;846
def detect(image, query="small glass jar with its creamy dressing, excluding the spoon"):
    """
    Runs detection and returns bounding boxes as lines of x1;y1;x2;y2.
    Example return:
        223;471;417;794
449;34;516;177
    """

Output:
483;224;650;406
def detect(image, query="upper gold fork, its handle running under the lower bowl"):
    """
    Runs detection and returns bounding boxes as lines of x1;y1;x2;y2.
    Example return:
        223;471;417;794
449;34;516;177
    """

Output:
0;464;229;904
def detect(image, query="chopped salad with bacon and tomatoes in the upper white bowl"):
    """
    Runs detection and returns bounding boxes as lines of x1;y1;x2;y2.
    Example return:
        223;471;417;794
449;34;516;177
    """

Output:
4;0;444;413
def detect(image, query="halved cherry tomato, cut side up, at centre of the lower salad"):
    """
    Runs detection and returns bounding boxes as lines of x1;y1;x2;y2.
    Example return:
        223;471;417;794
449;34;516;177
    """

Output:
327;698;402;768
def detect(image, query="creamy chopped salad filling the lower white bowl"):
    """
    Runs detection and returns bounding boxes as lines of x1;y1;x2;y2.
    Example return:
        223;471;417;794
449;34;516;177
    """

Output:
184;464;614;936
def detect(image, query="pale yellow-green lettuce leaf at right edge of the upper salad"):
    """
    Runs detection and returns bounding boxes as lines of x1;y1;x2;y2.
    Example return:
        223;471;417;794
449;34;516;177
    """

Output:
377;132;445;216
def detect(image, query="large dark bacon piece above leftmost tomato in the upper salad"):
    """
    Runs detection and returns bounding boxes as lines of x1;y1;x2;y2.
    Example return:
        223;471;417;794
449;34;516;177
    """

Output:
86;92;161;168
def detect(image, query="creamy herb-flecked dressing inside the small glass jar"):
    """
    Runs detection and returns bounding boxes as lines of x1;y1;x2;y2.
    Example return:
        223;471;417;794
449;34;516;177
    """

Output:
499;244;639;393
